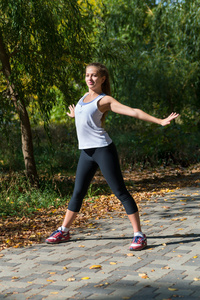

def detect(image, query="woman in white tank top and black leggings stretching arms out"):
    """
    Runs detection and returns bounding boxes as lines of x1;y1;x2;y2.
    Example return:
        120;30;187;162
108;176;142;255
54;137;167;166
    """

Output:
46;63;178;250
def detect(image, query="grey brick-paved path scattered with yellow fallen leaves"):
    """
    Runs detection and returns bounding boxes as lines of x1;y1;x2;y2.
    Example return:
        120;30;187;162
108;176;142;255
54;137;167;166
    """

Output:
0;188;200;300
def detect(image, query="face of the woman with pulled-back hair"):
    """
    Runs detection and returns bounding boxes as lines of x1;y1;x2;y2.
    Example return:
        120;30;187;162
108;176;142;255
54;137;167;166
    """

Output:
85;66;106;91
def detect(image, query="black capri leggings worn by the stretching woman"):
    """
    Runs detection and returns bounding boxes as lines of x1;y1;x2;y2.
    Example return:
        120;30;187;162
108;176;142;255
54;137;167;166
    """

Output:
68;143;138;215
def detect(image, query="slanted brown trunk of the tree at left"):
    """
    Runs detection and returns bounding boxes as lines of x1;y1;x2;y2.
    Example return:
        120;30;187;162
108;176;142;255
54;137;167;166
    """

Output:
0;31;38;186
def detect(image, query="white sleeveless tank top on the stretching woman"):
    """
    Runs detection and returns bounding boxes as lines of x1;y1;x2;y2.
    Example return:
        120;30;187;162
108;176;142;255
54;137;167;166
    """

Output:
75;94;112;149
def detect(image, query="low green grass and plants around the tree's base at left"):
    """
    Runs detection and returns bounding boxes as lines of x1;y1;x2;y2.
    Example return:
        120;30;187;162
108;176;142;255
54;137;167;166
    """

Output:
0;173;68;216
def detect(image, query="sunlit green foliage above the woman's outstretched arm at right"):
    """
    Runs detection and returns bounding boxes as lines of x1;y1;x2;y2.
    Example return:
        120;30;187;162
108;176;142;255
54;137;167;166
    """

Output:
91;0;200;125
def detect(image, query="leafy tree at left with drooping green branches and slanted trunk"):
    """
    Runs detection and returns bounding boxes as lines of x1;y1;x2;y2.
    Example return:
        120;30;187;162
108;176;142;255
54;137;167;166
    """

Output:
0;0;91;183
